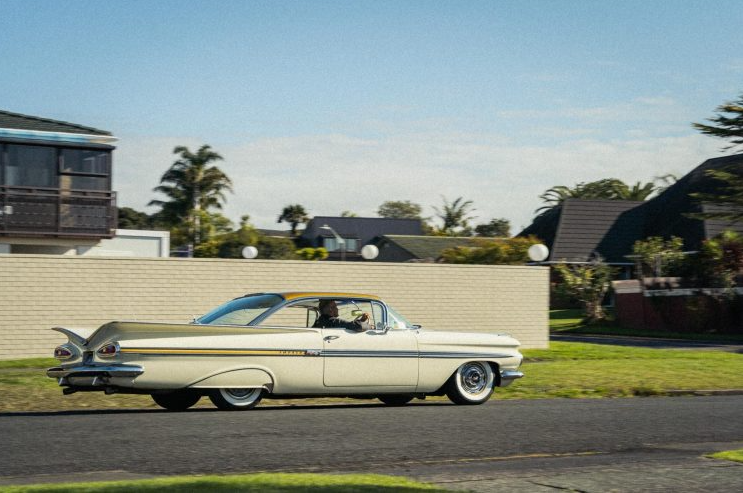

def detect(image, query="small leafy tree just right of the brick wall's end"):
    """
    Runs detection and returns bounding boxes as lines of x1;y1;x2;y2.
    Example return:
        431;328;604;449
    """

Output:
555;258;613;324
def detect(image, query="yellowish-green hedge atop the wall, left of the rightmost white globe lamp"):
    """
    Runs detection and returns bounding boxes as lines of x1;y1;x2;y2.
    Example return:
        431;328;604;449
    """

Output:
441;236;540;265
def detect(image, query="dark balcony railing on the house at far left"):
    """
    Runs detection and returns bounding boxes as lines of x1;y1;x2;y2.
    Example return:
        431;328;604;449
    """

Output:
0;186;116;238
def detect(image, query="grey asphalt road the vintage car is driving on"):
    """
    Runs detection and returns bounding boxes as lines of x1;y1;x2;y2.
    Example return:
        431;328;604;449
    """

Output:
0;396;743;491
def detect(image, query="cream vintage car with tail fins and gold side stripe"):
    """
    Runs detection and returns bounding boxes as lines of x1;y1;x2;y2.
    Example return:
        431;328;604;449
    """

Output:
47;293;523;411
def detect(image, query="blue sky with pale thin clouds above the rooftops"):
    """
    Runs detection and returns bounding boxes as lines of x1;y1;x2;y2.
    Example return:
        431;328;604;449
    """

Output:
0;0;743;232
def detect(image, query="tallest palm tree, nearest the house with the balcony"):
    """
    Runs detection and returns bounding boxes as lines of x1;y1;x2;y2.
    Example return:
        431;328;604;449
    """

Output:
149;145;232;247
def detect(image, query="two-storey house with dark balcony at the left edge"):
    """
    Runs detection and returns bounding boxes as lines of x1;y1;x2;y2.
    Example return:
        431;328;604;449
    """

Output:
0;110;169;256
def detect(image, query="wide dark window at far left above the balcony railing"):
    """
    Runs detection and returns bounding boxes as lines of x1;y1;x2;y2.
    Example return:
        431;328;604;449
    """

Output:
5;144;57;188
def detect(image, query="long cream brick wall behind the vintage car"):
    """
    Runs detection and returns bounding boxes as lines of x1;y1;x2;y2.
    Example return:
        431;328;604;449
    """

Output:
0;255;549;359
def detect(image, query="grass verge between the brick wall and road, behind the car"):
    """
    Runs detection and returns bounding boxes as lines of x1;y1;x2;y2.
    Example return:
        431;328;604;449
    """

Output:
0;342;743;412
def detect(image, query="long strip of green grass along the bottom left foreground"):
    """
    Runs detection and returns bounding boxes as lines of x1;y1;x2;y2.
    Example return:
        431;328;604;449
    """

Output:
2;473;447;493
